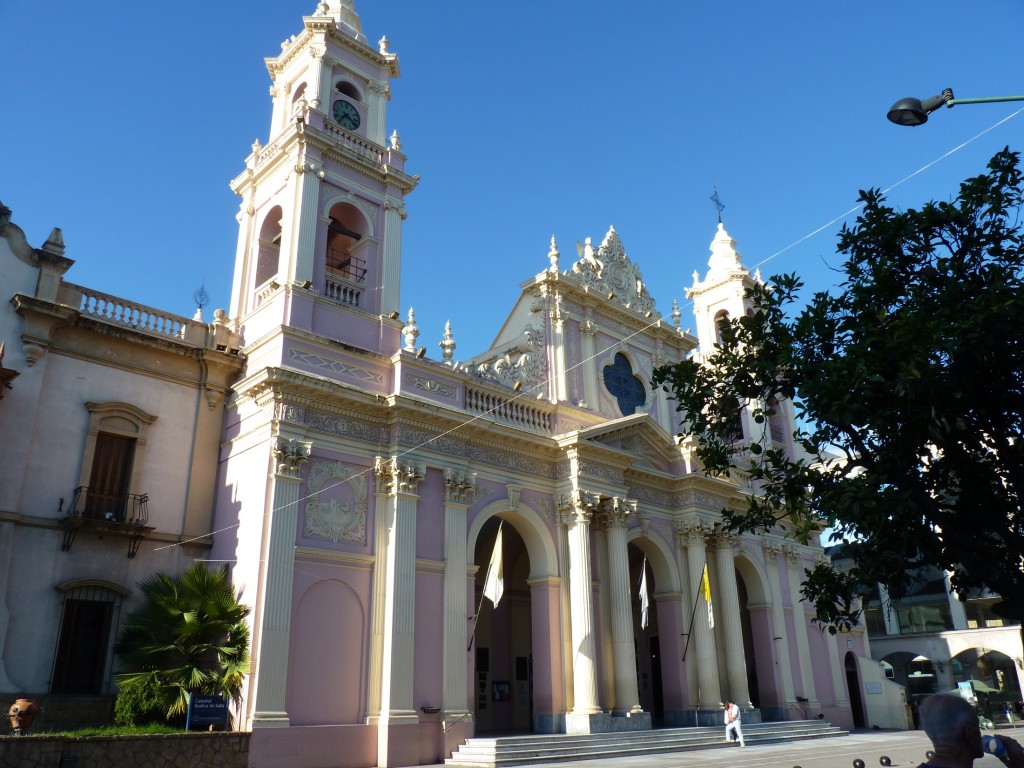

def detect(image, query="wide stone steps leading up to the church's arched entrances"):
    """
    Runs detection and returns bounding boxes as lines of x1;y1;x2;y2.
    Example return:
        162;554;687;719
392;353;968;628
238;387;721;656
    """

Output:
444;720;849;768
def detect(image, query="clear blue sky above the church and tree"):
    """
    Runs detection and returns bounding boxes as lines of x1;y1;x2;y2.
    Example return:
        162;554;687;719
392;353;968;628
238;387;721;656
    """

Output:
0;0;1024;358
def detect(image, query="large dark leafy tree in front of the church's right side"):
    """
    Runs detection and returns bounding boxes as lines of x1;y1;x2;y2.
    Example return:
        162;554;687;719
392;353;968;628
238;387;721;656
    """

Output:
654;147;1024;633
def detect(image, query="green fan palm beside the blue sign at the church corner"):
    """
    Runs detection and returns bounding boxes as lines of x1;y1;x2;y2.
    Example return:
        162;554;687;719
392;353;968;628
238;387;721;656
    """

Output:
115;562;249;719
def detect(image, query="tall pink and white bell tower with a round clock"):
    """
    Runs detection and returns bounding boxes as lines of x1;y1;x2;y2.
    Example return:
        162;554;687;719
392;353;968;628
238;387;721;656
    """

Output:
231;0;418;351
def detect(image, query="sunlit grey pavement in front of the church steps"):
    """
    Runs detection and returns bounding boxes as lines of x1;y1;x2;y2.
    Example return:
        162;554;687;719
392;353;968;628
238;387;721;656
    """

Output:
407;728;1024;768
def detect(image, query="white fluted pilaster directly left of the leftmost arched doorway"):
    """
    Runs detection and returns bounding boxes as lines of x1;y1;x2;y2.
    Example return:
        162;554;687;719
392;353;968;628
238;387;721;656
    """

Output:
441;469;476;721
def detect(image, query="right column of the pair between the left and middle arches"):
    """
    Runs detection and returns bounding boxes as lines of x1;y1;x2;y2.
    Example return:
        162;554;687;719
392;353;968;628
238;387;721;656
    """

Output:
605;498;643;714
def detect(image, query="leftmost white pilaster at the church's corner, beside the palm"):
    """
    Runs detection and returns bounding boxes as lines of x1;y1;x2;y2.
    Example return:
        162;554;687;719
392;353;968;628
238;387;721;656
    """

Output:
249;437;311;729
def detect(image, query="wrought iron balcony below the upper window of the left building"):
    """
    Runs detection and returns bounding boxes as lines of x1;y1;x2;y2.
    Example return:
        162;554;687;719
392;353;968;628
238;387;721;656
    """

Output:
57;485;153;557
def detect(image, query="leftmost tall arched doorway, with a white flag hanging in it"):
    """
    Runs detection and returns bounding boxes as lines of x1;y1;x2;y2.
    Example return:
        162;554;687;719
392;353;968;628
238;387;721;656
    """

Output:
472;516;534;735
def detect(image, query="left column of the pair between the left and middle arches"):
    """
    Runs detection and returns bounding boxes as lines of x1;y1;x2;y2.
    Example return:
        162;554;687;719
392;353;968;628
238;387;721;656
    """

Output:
567;492;601;727
